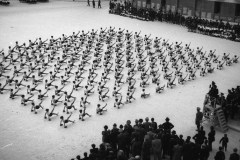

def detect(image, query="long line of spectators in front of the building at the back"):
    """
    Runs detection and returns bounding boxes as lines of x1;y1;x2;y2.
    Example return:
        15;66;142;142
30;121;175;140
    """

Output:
109;0;240;42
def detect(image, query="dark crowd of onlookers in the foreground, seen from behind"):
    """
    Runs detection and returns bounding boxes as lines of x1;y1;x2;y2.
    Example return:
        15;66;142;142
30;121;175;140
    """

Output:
71;117;240;160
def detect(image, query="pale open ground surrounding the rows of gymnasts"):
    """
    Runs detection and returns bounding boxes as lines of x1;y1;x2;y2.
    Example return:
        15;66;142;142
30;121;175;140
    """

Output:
0;1;240;160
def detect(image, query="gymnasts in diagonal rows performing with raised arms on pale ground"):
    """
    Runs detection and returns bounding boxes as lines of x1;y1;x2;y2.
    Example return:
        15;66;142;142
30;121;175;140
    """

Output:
0;26;239;127
